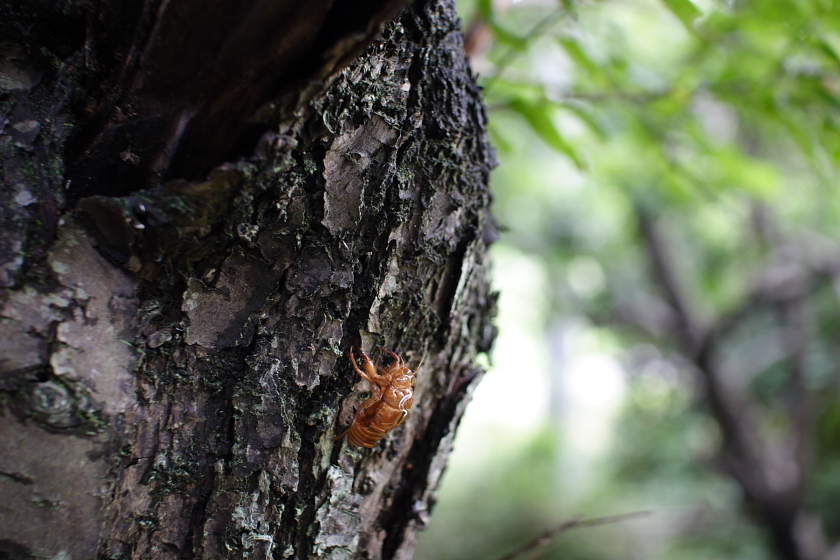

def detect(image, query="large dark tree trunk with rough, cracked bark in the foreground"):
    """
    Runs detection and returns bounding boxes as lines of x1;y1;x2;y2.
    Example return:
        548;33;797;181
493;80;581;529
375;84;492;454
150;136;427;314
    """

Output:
0;0;495;560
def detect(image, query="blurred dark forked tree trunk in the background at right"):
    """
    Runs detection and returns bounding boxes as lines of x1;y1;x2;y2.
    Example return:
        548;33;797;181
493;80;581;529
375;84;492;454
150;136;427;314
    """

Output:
636;206;814;560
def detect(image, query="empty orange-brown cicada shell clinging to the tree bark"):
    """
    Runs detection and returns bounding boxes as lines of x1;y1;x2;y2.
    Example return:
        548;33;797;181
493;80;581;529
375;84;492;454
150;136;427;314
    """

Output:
333;347;417;447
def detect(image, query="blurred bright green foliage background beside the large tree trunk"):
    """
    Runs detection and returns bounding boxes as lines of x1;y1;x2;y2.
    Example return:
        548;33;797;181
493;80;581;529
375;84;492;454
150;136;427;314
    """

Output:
415;0;840;560
